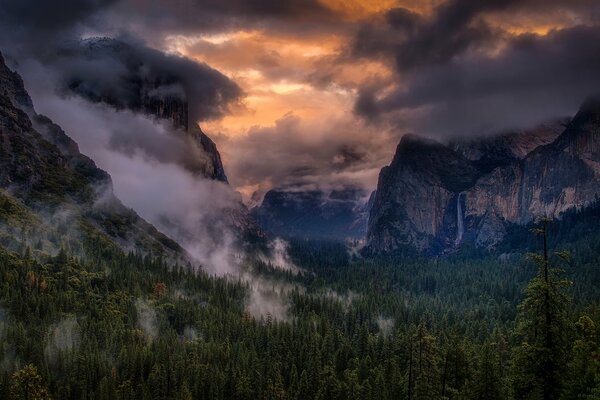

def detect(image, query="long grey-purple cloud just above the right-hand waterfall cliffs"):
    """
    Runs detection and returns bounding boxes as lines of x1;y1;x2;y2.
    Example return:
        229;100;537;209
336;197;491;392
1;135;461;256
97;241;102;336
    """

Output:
355;26;600;135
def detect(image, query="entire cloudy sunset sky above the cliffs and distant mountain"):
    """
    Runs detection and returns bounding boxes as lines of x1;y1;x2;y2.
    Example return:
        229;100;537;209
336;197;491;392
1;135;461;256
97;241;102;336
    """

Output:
0;0;600;201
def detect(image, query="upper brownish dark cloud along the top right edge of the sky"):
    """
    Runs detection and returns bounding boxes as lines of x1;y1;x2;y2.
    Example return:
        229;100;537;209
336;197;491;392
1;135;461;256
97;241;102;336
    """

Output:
351;0;600;69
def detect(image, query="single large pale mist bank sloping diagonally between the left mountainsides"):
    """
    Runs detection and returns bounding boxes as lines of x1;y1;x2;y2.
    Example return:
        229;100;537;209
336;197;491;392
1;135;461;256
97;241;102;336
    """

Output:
16;58;243;274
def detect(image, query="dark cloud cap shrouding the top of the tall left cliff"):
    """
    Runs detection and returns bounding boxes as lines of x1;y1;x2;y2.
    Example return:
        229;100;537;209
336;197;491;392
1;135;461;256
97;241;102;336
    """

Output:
47;38;242;123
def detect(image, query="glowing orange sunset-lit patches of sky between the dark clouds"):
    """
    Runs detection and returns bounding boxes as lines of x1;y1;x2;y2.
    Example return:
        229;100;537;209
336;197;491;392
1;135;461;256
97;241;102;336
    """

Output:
157;0;578;198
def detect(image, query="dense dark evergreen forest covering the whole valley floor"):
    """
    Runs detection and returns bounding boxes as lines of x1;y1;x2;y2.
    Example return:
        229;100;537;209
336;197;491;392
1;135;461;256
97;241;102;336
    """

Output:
0;220;600;400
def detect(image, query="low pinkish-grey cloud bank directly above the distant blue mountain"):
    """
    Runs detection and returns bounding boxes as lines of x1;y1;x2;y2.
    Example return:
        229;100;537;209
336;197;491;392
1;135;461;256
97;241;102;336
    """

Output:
215;113;397;200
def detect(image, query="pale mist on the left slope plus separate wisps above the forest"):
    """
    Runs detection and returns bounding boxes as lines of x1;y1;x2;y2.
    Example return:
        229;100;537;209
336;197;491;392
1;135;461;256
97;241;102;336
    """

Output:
14;55;299;322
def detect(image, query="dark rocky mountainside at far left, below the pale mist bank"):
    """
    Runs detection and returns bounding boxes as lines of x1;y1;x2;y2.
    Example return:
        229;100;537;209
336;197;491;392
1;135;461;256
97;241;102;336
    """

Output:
0;50;189;261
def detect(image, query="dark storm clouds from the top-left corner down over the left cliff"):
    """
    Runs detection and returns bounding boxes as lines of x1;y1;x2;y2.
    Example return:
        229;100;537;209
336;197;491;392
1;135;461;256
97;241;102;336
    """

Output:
0;0;246;120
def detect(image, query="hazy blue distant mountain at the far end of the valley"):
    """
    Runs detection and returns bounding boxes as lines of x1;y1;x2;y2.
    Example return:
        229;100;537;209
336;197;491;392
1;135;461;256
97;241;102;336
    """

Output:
252;188;370;239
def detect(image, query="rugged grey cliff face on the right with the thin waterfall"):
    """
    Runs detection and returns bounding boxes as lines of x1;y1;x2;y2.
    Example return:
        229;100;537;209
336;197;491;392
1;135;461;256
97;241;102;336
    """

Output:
367;104;600;254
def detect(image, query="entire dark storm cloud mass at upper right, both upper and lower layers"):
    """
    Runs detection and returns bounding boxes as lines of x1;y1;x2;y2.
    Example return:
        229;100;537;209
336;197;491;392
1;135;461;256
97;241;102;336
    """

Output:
354;0;600;136
